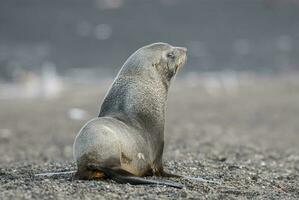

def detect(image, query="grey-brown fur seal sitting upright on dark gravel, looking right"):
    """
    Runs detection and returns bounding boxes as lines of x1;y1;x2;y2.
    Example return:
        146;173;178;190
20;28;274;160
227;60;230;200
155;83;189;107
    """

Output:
73;43;187;187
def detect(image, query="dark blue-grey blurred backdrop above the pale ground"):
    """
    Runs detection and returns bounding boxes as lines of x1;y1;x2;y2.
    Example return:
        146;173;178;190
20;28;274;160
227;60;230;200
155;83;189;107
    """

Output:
0;0;299;81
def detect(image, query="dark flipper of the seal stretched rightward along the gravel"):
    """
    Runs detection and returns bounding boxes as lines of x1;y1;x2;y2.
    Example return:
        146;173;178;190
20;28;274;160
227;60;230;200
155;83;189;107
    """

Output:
88;165;185;189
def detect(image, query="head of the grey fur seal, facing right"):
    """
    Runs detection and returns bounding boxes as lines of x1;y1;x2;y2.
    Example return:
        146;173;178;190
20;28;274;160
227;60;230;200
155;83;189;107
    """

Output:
121;42;187;85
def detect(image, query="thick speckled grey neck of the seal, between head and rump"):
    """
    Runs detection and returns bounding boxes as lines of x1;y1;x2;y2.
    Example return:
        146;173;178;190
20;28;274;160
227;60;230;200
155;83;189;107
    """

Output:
99;76;168;134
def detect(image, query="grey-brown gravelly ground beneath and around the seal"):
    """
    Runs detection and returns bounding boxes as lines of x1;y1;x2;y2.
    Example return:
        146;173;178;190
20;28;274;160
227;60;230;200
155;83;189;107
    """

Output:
0;77;299;199
